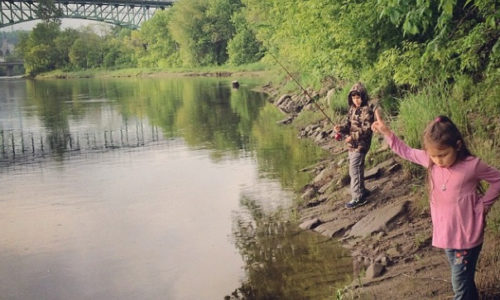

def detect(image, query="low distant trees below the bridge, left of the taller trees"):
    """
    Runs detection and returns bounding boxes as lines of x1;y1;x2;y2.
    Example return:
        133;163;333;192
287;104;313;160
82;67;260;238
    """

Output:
16;23;144;75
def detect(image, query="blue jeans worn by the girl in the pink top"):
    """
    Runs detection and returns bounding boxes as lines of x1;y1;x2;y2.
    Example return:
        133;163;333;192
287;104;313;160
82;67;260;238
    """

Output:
445;244;483;300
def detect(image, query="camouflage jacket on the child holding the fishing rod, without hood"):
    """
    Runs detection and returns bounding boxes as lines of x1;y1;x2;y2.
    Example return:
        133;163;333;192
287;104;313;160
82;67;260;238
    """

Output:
340;105;375;153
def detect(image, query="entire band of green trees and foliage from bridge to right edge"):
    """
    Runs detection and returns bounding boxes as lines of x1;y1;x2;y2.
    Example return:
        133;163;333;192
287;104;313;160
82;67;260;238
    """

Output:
14;0;500;88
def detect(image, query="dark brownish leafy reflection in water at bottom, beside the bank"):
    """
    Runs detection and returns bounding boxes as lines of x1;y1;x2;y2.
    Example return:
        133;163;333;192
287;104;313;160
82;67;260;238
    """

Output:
230;197;352;299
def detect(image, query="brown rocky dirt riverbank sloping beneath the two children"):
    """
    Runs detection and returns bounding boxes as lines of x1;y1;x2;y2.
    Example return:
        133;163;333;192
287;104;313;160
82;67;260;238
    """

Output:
267;82;500;299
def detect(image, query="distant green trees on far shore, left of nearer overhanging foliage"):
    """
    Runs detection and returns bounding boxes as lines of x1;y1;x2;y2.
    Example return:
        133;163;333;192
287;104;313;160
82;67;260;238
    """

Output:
13;0;264;75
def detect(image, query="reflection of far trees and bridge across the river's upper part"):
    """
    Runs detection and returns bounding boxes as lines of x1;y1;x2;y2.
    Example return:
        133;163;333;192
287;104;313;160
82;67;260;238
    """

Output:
0;79;265;163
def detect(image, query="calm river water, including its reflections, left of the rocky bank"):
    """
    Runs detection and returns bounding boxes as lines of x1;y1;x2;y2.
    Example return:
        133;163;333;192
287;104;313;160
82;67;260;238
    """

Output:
0;78;351;299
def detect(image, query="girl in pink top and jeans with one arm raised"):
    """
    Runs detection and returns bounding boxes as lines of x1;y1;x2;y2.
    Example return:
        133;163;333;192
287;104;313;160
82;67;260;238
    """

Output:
372;111;500;300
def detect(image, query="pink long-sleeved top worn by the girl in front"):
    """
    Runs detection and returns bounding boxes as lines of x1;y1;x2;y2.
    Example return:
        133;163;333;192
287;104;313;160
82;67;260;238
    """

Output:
385;133;500;249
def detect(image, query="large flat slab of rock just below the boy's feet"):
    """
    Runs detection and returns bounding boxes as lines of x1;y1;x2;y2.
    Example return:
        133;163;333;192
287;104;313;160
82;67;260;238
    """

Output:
347;201;409;238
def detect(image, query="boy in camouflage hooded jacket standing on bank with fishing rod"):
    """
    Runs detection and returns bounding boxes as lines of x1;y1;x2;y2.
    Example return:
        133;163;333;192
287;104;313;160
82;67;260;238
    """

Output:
334;82;374;208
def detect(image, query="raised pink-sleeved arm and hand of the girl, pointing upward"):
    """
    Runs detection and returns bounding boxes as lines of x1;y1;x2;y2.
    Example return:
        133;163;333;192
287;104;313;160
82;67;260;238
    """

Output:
372;109;429;168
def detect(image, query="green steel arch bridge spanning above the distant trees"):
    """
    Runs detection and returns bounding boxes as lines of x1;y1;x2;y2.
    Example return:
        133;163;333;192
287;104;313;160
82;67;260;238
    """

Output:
0;0;176;28
